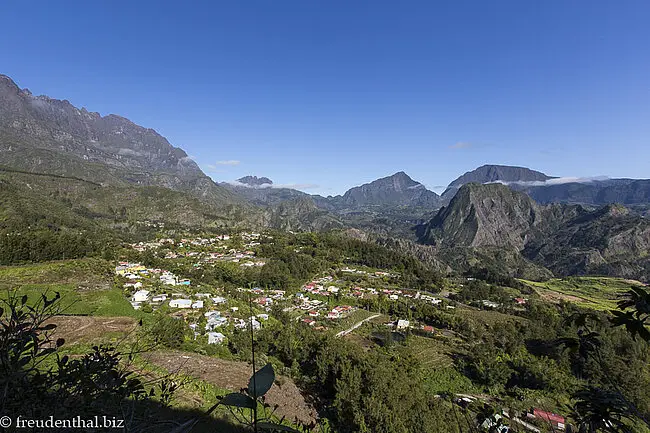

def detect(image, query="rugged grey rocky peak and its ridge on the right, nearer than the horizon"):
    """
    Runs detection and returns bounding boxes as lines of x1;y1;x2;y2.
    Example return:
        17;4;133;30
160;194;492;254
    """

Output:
416;184;650;280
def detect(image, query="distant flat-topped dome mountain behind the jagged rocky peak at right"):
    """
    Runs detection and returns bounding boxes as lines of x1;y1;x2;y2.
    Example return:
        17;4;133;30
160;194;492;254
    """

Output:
442;164;552;200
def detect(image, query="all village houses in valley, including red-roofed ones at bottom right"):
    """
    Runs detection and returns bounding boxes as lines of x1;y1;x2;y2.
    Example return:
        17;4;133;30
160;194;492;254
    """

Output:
102;226;576;431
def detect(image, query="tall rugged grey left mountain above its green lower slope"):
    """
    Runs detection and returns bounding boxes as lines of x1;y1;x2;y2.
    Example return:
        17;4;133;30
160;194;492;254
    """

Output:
0;75;241;204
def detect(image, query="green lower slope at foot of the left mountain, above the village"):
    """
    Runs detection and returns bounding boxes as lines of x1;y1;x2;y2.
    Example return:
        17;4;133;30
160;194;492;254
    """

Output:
0;169;248;231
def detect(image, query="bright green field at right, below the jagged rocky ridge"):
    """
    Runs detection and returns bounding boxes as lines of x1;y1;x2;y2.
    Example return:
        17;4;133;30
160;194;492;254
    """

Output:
520;277;641;310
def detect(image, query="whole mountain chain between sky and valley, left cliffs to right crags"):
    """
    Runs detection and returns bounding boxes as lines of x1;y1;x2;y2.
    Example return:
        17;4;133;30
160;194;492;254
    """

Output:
0;75;650;278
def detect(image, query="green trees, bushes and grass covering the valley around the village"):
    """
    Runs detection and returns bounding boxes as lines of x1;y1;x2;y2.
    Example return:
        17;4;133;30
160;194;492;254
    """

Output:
0;228;650;433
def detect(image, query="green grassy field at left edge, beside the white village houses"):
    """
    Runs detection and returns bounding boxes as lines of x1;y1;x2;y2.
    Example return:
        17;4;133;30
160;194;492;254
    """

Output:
0;259;139;317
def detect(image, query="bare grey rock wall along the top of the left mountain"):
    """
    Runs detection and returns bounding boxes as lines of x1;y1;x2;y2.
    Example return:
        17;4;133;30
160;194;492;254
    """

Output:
0;75;203;177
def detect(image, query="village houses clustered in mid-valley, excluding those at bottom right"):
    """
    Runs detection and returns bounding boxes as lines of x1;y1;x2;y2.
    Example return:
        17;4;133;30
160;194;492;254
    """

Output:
115;228;526;350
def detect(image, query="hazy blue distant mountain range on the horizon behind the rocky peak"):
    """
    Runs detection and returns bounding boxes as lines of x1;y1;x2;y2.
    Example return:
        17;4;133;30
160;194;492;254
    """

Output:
230;165;650;213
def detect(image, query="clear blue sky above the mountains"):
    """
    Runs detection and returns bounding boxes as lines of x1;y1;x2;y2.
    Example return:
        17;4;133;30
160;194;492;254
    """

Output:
0;0;650;195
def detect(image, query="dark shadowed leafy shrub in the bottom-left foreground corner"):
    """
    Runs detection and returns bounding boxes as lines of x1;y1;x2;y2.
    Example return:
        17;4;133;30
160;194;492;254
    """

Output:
0;292;182;432
